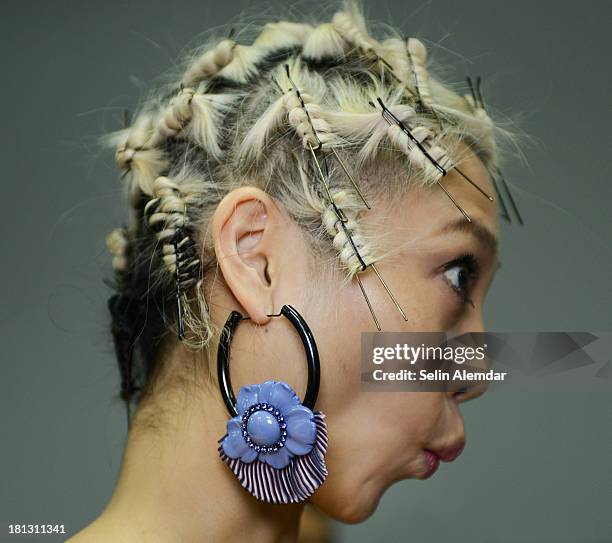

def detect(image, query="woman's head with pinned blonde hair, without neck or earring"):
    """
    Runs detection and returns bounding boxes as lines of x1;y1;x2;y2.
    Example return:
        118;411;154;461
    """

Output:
109;4;498;521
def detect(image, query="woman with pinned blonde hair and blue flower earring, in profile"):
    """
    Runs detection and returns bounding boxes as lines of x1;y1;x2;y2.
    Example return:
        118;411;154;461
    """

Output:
71;3;506;543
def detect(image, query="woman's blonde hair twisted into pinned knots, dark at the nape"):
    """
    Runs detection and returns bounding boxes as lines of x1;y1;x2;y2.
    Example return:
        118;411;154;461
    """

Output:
109;1;506;408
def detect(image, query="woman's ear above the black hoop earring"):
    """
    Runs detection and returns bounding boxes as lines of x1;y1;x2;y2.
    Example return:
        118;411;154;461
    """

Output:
211;187;287;324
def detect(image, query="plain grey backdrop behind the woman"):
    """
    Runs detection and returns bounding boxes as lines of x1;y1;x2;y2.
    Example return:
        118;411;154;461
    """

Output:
0;0;612;543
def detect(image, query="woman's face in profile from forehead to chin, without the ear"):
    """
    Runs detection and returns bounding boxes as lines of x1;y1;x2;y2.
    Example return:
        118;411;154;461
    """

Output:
290;144;498;522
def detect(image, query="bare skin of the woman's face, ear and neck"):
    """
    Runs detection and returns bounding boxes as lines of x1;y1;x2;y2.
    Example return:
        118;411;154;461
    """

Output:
69;144;498;543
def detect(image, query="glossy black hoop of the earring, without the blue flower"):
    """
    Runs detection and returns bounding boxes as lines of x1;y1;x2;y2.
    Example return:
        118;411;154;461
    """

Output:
217;305;321;417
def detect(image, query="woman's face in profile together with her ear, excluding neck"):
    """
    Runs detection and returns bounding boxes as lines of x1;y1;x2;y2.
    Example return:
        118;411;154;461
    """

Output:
213;142;498;522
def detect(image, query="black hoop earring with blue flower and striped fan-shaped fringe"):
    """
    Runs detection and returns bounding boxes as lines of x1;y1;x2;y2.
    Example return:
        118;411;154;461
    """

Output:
217;305;327;504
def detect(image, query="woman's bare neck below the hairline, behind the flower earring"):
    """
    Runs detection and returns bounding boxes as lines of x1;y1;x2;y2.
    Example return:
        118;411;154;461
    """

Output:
98;387;303;543
